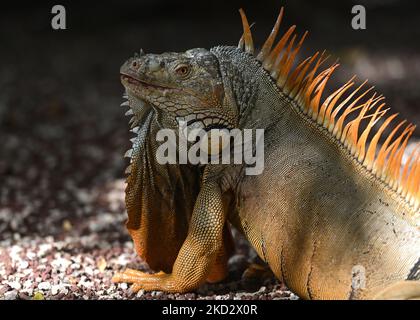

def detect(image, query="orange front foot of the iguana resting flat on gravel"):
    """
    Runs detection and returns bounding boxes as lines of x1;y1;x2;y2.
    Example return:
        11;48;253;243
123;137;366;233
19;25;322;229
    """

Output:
112;269;181;293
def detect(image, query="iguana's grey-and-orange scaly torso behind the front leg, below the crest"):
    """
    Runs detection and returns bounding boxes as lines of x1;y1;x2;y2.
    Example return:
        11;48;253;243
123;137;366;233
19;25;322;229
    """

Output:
217;49;420;299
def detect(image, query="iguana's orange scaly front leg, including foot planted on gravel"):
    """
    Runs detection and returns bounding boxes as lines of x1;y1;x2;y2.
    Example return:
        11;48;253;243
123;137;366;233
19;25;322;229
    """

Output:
112;175;226;292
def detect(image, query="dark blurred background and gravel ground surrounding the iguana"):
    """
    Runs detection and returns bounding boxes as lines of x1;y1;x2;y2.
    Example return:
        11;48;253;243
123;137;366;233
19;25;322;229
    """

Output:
0;0;420;299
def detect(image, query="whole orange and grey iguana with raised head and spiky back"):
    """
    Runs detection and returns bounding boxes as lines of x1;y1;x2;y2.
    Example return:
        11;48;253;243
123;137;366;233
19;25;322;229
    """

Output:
113;8;420;299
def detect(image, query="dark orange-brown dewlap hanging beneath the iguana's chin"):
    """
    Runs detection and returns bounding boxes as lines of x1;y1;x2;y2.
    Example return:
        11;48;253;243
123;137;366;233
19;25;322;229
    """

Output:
118;50;233;289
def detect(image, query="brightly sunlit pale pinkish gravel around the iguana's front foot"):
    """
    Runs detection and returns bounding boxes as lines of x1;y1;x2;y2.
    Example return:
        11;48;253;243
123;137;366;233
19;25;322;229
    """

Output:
0;180;297;299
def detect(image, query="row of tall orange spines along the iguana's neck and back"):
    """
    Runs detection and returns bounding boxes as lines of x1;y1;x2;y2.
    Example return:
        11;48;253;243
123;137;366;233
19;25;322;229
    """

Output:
238;8;420;210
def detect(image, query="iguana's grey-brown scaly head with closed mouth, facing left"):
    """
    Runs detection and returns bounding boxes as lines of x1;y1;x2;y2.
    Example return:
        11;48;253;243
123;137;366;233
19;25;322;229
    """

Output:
120;49;237;130
